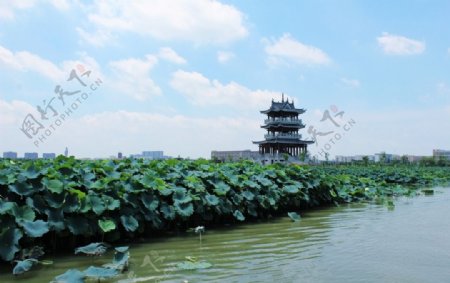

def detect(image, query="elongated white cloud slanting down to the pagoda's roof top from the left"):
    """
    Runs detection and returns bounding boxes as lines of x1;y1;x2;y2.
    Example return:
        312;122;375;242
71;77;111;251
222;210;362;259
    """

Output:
170;70;279;111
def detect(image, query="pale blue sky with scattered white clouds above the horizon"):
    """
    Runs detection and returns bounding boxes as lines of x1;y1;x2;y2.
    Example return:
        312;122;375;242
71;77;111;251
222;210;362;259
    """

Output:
0;0;450;160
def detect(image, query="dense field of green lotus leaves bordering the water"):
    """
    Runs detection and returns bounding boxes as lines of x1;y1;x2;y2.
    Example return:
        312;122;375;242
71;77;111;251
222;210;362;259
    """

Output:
0;156;450;274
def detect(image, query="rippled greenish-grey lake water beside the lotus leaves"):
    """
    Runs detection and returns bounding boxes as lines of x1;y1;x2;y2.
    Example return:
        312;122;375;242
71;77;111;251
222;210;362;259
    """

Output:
0;188;450;283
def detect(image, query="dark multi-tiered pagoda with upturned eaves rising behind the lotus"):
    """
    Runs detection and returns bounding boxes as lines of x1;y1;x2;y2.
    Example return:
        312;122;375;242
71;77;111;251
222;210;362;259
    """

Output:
253;95;313;157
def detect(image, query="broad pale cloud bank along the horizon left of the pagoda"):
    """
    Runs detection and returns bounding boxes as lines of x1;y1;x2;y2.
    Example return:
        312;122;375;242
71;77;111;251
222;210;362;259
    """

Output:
0;100;264;158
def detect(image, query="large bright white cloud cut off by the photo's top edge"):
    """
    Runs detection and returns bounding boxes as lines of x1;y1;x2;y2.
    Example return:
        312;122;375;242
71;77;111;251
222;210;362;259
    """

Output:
78;0;248;44
